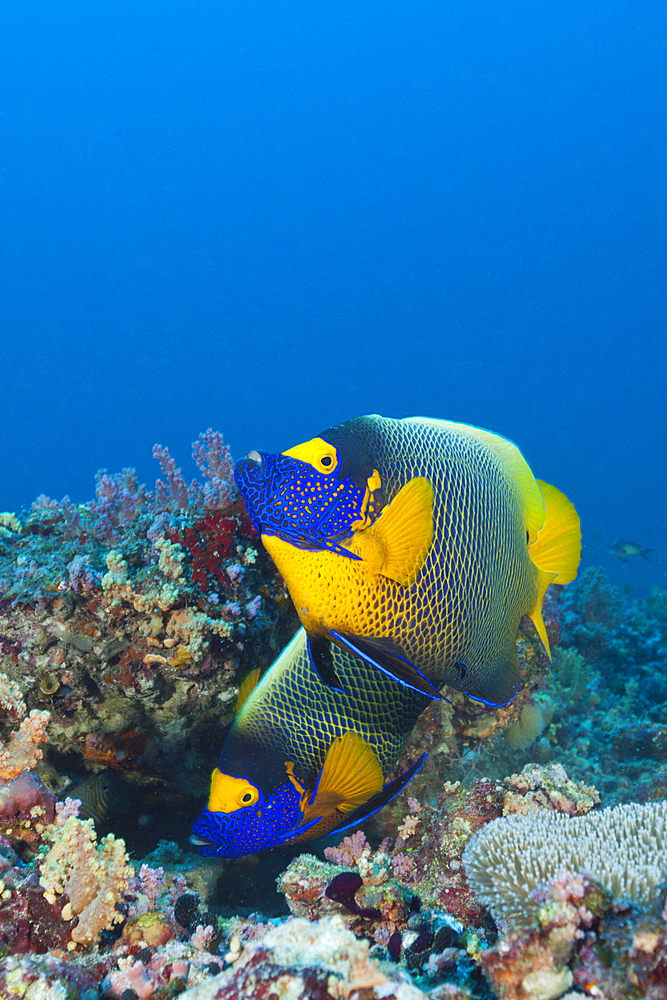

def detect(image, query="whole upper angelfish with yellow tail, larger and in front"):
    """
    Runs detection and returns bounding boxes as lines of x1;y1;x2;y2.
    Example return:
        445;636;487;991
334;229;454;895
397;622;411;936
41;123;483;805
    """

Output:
235;415;581;705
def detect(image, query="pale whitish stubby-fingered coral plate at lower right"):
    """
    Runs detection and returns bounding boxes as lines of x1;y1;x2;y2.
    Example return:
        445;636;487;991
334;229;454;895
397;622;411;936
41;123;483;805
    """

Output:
463;802;667;927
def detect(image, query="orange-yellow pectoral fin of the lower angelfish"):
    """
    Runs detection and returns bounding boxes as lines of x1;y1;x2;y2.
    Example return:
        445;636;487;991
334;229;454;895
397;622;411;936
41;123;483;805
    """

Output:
304;732;384;820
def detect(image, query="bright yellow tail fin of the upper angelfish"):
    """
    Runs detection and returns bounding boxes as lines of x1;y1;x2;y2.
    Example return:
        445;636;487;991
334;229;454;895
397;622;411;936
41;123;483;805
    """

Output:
528;479;581;657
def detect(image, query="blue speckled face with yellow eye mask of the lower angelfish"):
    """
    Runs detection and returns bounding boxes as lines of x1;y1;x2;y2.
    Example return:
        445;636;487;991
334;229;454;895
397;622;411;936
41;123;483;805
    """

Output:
190;769;320;858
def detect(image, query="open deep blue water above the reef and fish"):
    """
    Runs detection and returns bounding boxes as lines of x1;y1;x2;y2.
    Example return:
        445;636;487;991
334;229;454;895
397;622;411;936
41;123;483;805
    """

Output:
0;0;667;592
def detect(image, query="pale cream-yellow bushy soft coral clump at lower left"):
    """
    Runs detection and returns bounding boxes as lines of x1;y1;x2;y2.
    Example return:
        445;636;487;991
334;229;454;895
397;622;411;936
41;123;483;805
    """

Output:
40;816;134;947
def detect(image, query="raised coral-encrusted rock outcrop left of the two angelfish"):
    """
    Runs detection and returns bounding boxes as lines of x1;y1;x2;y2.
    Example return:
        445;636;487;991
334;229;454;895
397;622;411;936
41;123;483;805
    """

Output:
0;430;297;808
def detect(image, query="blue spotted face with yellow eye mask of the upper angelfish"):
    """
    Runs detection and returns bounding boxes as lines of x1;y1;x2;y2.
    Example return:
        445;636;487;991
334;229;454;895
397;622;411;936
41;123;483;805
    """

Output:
234;437;382;559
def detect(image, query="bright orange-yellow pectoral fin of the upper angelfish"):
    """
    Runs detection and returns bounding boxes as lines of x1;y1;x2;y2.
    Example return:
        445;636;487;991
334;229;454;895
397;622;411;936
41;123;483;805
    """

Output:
358;476;433;587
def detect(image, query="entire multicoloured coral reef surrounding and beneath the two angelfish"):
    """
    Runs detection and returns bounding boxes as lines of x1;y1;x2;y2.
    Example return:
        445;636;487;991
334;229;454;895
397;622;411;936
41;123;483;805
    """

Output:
0;430;667;1000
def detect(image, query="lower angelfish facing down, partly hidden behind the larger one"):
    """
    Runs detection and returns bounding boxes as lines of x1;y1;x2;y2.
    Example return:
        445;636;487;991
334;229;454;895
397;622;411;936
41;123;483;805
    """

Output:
190;629;430;857
